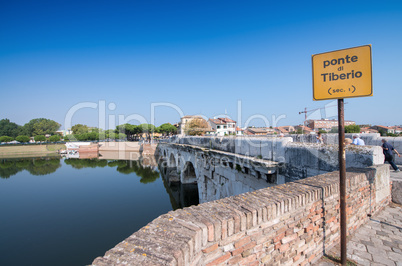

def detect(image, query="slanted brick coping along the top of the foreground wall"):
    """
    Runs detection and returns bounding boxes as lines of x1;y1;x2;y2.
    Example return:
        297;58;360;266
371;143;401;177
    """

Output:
93;166;383;265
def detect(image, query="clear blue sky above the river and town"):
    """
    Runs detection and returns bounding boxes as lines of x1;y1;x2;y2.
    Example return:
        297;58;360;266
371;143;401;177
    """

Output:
0;0;402;127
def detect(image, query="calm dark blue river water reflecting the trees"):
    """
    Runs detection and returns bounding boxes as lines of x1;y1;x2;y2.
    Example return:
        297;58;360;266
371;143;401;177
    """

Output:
0;158;198;265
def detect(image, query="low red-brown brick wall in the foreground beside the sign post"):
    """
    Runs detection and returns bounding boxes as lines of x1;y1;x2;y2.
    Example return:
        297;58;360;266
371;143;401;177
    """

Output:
93;165;390;265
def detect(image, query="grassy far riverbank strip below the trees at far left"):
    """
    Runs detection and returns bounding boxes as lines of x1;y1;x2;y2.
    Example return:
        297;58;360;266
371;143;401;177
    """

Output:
0;144;66;158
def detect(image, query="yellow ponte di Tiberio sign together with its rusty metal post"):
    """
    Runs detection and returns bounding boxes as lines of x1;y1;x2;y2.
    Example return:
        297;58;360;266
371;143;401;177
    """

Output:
311;45;373;265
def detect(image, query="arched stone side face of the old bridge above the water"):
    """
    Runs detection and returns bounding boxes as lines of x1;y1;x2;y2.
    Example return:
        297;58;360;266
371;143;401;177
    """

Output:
158;143;285;203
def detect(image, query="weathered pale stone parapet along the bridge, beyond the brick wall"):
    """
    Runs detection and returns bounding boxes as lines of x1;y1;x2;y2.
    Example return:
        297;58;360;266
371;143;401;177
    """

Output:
160;137;384;181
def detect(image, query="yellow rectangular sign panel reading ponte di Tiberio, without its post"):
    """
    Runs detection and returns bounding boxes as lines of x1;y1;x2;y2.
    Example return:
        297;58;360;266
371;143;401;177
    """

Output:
311;45;373;101
